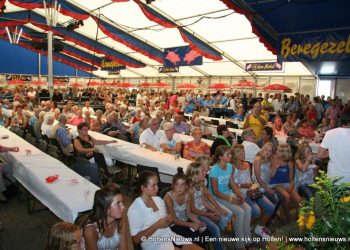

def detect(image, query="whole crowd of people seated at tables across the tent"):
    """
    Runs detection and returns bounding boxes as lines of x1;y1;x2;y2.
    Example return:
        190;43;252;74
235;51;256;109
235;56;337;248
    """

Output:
0;87;350;249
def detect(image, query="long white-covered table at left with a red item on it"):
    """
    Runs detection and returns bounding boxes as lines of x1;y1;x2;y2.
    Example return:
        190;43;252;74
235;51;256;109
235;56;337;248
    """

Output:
0;126;98;223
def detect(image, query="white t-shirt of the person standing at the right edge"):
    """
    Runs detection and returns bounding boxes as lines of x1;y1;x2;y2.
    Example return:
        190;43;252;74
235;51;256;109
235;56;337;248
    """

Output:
321;128;350;184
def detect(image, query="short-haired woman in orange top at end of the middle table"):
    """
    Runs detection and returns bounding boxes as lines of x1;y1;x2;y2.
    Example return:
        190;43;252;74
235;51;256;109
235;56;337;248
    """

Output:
184;127;210;161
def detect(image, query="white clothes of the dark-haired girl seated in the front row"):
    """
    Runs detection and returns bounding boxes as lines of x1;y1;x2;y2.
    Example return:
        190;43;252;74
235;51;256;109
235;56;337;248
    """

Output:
128;196;188;250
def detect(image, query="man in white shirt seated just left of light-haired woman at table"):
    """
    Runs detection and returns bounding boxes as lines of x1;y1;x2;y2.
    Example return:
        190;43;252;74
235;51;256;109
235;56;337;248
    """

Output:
140;118;163;151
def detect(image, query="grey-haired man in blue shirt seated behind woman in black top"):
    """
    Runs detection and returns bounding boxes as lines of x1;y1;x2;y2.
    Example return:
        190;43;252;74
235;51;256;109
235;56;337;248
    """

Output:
50;114;73;155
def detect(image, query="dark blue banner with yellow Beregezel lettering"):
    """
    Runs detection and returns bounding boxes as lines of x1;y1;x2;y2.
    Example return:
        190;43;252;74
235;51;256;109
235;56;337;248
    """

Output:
278;30;350;62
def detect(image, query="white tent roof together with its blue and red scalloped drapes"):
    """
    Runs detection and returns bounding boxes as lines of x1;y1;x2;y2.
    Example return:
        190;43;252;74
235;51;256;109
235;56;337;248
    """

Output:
0;0;318;78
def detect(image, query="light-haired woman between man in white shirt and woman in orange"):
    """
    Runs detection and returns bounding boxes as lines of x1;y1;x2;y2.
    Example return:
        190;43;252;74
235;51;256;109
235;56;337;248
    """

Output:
160;122;181;155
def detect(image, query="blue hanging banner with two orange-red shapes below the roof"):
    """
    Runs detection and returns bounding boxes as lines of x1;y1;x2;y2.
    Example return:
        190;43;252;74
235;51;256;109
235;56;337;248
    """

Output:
163;46;203;67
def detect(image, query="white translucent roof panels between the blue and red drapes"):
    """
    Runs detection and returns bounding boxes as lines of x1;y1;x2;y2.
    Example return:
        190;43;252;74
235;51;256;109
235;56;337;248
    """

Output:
0;0;312;78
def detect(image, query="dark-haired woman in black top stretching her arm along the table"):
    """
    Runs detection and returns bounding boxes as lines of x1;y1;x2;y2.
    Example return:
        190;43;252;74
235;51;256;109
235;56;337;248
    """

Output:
73;122;117;160
